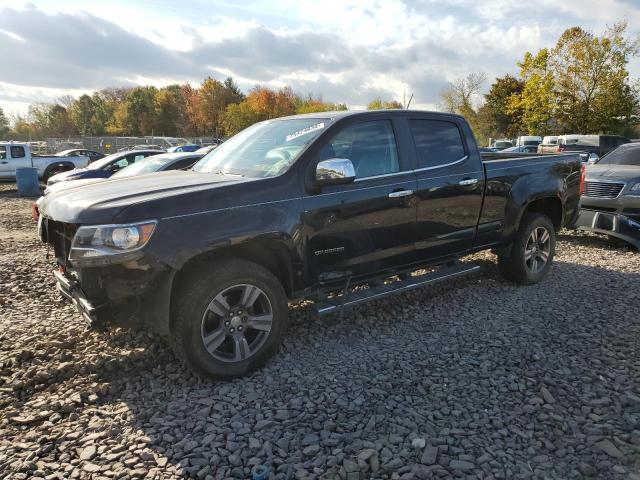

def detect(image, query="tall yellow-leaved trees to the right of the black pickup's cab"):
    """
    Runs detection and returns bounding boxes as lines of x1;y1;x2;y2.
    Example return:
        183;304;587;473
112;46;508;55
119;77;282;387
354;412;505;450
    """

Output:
440;22;640;143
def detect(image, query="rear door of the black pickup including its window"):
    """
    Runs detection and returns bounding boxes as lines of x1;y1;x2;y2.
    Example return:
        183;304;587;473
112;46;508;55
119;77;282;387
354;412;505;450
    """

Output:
407;115;484;260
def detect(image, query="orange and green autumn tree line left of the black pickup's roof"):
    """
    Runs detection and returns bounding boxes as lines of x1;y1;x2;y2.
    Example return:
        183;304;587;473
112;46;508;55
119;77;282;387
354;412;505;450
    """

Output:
0;77;347;140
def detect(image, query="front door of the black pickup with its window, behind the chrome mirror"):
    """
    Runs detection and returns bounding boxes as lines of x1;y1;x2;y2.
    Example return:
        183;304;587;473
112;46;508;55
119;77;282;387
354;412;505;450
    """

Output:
303;119;417;281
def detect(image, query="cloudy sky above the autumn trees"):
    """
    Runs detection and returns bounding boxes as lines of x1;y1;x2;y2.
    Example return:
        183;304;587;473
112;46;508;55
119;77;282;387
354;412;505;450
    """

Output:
0;0;640;114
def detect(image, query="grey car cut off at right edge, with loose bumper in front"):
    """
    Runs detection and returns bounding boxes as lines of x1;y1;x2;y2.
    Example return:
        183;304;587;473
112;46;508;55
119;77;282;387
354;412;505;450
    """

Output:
575;143;640;250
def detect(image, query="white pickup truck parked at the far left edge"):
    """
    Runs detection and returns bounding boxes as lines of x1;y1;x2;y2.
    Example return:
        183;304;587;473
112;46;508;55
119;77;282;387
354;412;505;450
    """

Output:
0;142;89;182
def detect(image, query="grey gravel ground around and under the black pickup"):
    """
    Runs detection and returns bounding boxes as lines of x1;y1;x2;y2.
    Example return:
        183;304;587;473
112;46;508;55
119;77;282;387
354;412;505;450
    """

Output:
0;182;640;480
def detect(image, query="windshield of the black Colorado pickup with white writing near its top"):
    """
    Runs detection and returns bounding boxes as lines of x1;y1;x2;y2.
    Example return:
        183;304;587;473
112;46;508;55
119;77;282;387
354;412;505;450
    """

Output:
193;118;331;178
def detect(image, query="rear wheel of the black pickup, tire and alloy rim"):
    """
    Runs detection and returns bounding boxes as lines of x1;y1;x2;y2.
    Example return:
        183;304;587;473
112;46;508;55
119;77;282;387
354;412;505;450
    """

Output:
498;213;556;285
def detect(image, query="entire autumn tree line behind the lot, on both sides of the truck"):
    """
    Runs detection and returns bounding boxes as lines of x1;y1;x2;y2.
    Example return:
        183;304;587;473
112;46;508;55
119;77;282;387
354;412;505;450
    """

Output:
0;22;640;143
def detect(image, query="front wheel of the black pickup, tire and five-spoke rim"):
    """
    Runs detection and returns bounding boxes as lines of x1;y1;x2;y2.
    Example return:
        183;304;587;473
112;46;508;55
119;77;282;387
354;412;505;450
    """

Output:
172;260;288;379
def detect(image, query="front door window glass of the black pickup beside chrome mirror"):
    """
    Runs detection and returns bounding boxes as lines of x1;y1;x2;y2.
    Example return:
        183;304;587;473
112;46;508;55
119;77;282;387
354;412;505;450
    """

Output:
319;120;400;178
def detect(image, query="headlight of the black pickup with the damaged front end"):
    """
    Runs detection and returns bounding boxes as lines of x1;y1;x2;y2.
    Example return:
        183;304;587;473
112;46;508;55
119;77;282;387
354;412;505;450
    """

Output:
69;220;158;261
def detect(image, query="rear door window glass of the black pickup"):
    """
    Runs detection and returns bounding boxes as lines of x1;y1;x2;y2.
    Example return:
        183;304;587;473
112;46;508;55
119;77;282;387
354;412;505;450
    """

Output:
410;120;465;168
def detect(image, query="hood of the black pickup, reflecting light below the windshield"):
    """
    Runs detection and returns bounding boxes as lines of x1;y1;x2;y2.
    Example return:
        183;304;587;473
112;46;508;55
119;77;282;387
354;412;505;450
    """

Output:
39;171;249;224
